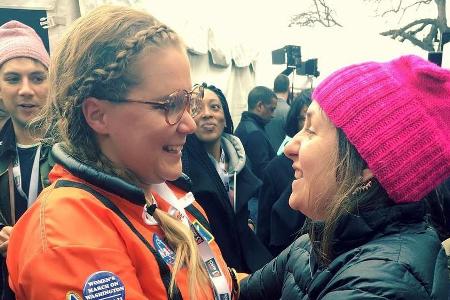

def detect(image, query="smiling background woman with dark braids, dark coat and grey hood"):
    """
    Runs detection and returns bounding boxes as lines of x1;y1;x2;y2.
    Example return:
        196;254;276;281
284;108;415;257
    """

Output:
182;84;272;273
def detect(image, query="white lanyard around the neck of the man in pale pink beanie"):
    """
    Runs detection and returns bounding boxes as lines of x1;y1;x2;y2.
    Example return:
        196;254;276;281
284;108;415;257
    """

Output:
13;145;41;207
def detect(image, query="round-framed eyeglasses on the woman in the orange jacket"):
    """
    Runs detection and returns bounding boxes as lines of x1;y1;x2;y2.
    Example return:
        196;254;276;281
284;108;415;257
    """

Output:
115;85;204;125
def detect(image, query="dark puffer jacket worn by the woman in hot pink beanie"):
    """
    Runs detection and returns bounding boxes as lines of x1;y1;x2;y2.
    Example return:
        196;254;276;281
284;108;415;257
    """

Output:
239;202;449;300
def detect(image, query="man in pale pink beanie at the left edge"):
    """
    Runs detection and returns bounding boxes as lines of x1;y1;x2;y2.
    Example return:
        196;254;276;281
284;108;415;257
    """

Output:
0;21;50;300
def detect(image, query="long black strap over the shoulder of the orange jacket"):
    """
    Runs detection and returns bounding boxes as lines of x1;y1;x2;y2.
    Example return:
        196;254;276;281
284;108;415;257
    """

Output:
55;180;183;300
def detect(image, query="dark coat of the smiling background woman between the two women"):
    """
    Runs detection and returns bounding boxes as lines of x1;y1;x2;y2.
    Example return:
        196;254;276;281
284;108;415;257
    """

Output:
182;135;272;273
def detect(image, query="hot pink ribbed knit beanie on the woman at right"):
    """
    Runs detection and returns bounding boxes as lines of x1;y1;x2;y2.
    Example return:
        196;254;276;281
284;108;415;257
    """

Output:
313;55;450;203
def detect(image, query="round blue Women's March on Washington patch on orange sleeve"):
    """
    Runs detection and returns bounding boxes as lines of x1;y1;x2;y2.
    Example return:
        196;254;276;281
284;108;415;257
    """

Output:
83;271;125;300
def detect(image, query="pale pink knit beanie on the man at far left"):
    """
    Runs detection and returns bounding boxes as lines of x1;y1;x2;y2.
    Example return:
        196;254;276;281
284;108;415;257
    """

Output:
0;20;50;68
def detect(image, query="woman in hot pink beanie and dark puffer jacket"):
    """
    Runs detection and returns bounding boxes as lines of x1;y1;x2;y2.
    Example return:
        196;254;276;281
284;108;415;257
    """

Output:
239;55;450;300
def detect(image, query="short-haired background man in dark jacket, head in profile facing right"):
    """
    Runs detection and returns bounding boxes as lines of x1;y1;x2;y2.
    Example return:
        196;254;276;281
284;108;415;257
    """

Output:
234;86;277;179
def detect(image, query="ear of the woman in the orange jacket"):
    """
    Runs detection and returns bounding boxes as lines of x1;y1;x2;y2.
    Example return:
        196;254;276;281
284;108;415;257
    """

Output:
81;97;109;134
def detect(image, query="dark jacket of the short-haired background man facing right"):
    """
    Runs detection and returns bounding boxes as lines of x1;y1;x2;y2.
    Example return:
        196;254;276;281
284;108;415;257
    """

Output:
234;111;276;179
